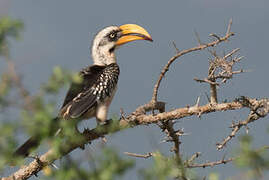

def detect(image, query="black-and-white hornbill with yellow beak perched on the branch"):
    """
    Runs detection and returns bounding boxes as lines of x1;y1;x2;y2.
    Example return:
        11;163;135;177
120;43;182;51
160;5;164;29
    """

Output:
15;24;152;156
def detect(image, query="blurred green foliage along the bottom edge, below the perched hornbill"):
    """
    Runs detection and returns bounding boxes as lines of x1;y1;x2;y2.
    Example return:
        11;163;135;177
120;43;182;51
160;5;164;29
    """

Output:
45;148;134;180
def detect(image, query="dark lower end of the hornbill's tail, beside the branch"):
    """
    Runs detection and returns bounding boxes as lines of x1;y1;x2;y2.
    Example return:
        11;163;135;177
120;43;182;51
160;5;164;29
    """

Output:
14;137;39;157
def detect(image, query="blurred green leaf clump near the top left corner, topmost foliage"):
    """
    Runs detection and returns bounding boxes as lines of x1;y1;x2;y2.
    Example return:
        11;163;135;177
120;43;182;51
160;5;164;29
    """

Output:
0;17;23;55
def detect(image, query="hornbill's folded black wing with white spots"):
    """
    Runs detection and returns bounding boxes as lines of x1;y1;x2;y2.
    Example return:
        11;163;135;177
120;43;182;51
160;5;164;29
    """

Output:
61;64;119;119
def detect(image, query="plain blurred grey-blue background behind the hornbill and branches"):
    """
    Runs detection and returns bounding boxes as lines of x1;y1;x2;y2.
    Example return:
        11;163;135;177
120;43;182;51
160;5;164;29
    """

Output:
0;0;269;180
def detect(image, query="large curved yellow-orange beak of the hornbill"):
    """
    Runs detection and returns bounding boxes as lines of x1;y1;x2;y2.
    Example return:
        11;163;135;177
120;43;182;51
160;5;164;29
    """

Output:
116;24;153;46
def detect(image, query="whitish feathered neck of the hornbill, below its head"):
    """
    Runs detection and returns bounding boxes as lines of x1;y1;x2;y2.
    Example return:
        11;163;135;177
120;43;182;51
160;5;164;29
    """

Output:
92;46;116;66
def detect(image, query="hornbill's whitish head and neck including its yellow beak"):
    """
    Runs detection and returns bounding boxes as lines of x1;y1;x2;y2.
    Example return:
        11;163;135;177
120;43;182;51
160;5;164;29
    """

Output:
92;24;152;65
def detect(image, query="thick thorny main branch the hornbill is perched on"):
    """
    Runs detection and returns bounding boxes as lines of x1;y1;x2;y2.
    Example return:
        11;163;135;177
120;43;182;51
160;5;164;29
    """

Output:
3;98;268;180
